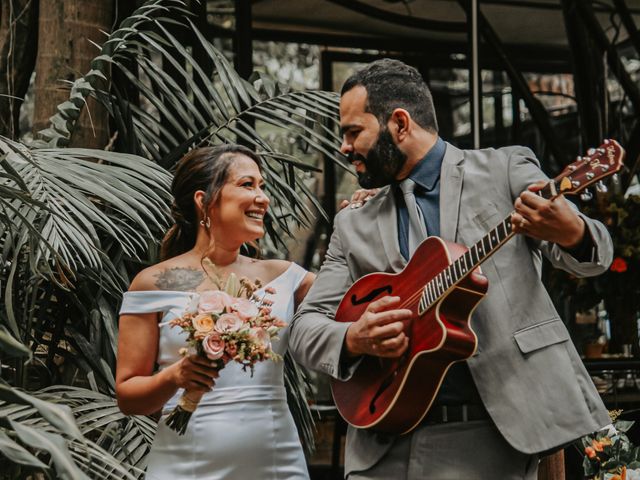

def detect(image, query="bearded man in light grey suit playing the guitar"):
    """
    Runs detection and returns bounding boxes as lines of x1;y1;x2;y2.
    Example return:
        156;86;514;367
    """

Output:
290;59;612;480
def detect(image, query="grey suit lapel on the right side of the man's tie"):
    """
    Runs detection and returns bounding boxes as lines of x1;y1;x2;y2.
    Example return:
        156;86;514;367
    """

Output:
440;143;464;241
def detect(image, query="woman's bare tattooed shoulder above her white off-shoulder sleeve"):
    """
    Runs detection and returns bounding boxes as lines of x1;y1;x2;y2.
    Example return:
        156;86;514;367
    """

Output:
129;257;206;291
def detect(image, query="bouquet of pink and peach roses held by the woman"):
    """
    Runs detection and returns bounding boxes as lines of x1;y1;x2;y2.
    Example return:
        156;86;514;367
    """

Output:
166;262;286;435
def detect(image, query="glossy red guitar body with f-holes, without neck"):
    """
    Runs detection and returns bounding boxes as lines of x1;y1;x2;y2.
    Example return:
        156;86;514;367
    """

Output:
331;237;488;434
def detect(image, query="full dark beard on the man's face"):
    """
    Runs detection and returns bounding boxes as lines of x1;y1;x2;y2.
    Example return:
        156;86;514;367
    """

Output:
350;128;407;188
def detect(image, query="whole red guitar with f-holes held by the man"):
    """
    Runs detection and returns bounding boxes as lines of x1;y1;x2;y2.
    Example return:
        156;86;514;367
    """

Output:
331;140;624;434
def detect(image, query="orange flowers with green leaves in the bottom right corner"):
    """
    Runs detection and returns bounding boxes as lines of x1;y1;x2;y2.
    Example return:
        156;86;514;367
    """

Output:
575;410;640;480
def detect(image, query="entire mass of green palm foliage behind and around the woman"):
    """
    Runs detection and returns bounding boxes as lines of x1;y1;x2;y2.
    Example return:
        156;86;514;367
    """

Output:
0;0;346;478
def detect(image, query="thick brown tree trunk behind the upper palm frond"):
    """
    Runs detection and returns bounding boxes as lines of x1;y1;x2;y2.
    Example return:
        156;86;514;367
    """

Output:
33;0;114;148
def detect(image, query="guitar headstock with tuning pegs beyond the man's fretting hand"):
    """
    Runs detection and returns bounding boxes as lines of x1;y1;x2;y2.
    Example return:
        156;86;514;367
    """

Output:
554;140;624;195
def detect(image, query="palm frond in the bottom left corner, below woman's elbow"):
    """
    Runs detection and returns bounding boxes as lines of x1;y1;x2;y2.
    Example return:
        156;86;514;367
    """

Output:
0;385;155;480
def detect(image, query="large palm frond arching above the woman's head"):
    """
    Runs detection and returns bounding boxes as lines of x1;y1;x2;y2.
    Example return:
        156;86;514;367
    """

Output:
33;0;347;245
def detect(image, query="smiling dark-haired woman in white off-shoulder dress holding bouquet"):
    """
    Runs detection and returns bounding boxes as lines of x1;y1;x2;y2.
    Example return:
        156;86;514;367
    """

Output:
116;145;314;480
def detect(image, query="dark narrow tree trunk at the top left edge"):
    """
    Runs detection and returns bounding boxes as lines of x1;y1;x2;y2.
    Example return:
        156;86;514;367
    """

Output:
0;0;38;139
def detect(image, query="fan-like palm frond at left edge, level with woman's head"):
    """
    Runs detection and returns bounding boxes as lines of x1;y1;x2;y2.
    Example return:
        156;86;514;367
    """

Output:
0;137;170;288
